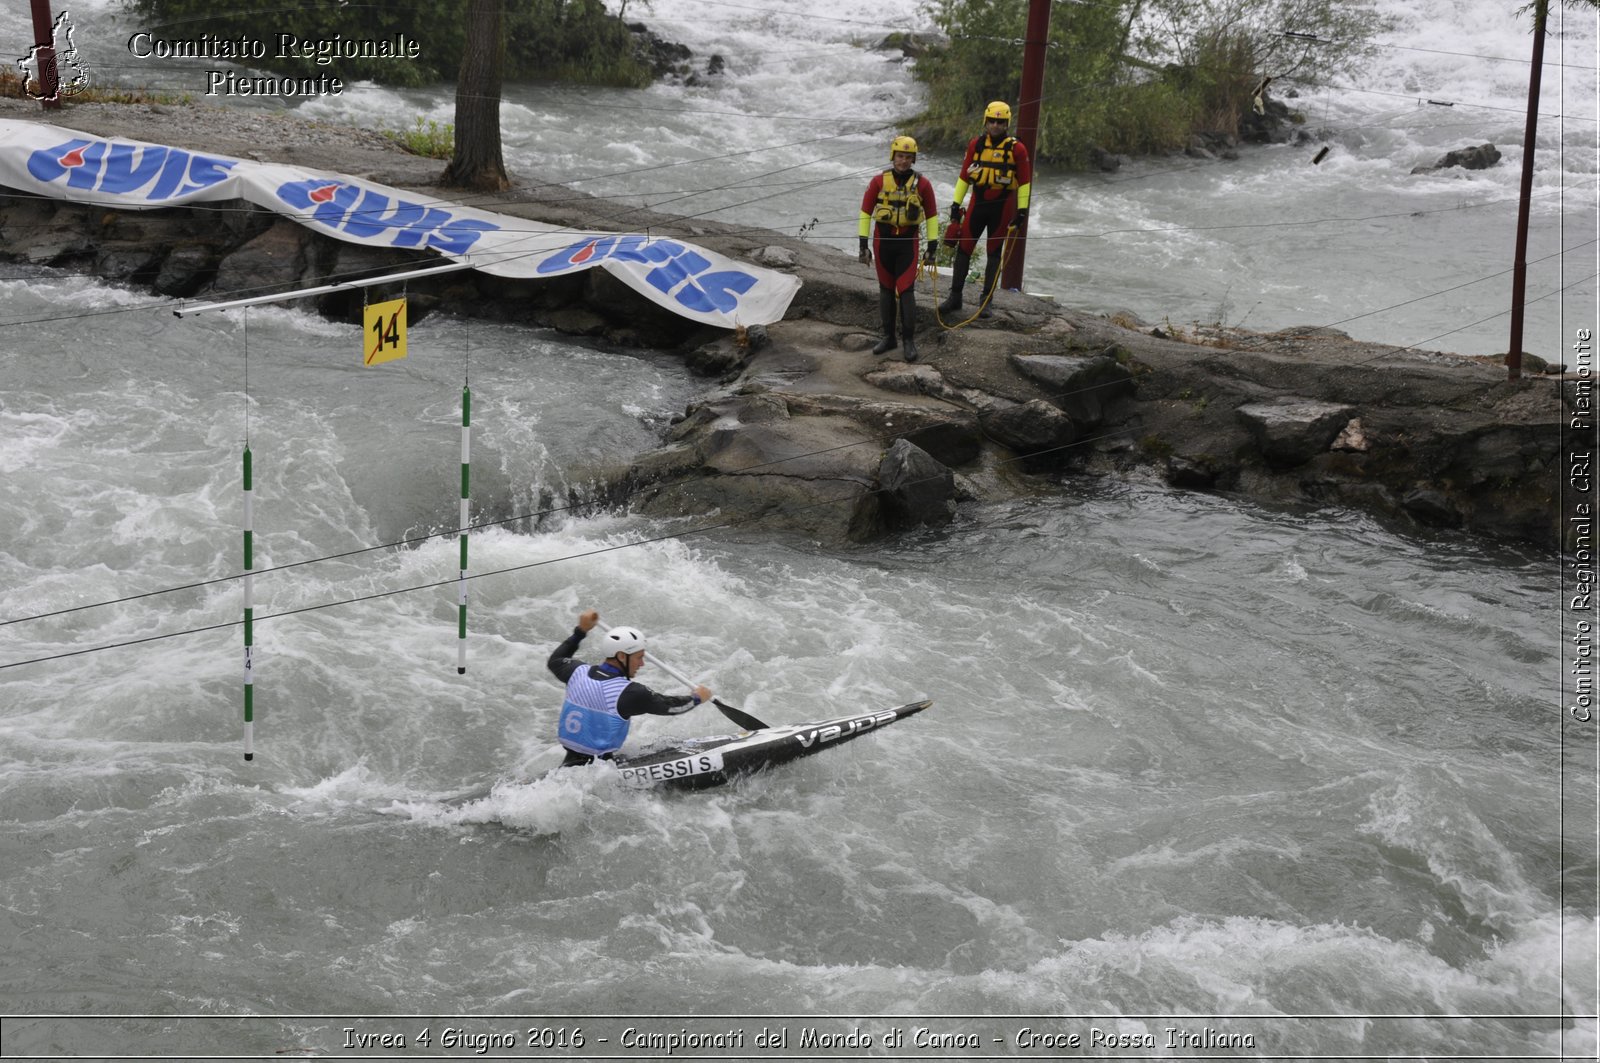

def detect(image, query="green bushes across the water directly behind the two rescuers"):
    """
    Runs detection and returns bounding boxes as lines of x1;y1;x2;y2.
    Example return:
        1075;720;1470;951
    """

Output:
917;0;1387;165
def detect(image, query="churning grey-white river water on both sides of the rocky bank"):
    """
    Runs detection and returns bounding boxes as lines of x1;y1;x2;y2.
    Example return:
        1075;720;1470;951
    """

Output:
0;0;1597;1060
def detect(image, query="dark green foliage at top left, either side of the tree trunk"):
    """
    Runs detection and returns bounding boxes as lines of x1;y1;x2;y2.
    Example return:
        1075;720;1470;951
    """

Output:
123;0;654;86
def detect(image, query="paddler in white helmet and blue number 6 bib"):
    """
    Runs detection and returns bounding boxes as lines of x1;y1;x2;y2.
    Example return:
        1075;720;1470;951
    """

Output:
546;608;710;768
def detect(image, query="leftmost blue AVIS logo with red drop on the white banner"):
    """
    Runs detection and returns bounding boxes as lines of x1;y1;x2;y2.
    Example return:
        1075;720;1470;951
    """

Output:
27;138;237;202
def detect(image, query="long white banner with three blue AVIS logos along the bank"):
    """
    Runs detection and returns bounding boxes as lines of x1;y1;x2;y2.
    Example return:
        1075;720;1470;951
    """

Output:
0;120;800;328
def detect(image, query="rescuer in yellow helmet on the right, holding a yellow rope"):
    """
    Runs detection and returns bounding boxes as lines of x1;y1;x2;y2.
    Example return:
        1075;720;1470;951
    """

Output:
939;99;1034;317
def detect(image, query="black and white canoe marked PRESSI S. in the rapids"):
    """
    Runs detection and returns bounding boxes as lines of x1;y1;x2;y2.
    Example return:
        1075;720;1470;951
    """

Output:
611;701;933;789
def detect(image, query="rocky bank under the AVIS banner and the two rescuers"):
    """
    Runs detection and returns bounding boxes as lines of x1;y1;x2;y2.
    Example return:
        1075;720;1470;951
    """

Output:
0;101;1574;549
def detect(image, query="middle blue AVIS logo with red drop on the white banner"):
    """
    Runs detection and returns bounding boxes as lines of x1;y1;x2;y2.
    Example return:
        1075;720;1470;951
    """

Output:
278;178;499;255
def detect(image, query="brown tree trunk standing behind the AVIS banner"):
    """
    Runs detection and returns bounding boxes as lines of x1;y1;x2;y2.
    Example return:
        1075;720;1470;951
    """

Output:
438;0;510;192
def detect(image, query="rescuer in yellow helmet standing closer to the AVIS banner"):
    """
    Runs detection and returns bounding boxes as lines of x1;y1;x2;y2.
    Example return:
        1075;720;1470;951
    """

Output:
856;136;939;362
